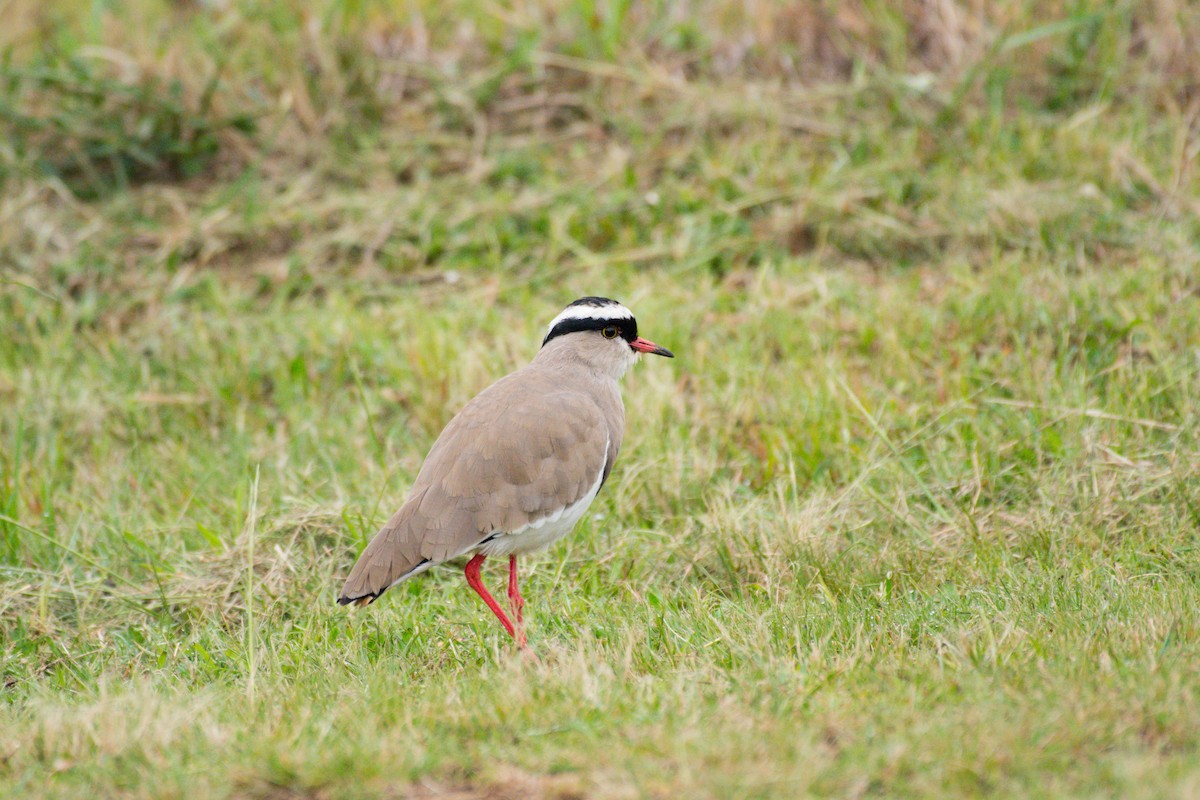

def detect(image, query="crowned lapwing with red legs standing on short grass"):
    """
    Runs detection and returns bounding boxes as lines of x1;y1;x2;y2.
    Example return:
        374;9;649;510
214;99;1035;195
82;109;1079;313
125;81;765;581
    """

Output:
337;296;674;649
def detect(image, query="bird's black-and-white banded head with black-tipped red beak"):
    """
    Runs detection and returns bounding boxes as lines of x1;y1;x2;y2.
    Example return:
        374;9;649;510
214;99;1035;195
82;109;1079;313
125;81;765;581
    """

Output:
541;297;674;378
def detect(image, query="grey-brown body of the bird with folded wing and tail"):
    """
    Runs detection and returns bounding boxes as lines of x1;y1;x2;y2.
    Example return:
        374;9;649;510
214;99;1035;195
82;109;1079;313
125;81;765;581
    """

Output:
338;367;623;604
